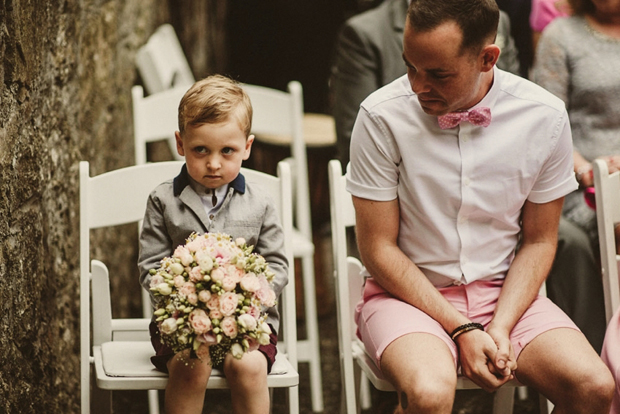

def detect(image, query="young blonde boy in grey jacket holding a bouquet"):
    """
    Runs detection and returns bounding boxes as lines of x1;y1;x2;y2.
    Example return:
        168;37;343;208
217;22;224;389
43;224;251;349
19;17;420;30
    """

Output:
138;75;288;414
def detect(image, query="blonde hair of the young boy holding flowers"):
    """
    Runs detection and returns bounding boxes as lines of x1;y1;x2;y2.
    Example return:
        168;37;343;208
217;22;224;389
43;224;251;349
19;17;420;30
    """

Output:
179;75;252;137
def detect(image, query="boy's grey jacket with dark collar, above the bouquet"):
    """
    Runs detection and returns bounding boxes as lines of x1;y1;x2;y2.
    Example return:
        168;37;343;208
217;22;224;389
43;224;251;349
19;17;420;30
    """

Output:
138;165;289;331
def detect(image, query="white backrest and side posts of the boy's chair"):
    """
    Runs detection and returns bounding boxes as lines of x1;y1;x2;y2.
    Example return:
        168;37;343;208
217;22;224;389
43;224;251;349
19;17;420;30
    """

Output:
80;161;297;407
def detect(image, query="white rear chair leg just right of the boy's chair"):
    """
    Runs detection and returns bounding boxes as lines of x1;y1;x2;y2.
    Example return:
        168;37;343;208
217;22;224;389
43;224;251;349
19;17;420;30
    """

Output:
299;255;323;412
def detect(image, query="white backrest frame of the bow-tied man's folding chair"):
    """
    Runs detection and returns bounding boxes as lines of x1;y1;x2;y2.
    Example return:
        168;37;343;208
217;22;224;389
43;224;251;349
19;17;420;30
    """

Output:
328;160;364;413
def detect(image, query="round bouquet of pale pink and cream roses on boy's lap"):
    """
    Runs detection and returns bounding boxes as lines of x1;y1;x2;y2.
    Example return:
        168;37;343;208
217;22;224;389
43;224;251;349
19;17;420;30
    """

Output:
150;233;276;365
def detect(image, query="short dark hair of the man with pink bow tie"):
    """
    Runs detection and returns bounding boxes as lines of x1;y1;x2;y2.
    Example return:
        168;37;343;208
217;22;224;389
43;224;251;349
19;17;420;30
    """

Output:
407;0;499;51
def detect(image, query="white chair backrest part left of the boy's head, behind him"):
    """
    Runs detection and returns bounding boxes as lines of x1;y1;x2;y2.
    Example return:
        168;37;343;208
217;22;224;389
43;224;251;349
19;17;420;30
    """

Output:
131;85;189;165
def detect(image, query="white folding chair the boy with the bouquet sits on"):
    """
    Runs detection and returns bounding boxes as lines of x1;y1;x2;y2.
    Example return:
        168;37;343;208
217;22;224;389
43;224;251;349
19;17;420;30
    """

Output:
80;161;299;414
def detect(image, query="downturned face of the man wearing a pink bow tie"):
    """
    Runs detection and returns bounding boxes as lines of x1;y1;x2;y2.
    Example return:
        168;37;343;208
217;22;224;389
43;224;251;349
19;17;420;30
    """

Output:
403;21;488;116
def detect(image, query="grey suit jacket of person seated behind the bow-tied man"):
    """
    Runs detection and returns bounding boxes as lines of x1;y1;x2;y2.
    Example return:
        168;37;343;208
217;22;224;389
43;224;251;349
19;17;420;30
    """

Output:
330;0;519;163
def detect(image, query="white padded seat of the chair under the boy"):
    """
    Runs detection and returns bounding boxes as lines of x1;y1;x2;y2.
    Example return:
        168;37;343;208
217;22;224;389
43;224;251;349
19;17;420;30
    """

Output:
93;341;299;390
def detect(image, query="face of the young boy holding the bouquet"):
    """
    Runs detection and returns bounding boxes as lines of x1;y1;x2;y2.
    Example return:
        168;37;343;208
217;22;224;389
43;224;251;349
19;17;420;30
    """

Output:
176;119;254;188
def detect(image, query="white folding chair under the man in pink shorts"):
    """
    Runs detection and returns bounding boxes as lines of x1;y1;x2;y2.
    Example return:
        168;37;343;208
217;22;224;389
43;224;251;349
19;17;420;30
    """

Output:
328;160;547;414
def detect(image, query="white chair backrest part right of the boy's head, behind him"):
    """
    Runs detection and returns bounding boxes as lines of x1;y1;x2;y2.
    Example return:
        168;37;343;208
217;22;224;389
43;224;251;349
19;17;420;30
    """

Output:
243;81;312;240
